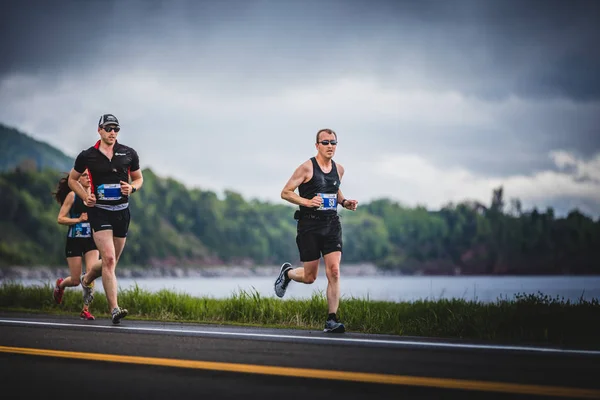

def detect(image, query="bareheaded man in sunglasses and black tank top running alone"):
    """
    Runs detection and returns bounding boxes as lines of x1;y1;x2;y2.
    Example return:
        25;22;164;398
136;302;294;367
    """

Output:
275;129;358;333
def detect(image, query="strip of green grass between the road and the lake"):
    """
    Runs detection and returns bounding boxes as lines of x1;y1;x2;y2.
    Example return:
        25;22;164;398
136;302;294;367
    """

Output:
0;282;600;348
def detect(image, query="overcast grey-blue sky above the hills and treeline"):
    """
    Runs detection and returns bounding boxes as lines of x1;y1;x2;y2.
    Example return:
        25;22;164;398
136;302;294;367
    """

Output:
0;0;600;217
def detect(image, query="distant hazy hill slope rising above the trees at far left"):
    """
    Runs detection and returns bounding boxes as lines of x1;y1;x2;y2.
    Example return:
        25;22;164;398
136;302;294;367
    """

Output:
0;124;74;171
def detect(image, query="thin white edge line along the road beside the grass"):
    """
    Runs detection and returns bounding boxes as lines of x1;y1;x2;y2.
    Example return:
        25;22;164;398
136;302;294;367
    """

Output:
0;319;600;356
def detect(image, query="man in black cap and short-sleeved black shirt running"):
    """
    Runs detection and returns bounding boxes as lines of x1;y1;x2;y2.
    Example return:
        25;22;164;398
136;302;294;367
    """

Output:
69;114;144;324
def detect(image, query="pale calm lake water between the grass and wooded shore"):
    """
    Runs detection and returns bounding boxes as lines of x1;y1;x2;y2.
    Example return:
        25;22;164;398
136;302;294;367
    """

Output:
11;276;600;302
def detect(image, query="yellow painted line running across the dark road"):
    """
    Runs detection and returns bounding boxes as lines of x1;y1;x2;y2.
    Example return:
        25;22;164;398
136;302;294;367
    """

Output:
0;346;600;399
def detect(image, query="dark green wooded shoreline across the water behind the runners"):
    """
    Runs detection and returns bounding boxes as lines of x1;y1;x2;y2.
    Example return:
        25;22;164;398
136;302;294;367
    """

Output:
0;125;600;274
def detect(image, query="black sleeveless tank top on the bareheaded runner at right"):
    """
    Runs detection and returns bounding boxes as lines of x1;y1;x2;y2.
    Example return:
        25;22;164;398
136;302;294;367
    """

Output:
298;157;341;214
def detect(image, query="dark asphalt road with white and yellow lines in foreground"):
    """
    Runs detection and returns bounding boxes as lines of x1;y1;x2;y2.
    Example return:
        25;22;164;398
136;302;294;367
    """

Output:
0;312;600;400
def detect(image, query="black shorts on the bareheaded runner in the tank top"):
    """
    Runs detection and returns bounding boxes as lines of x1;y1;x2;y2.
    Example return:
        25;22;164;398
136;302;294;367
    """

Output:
296;215;343;262
